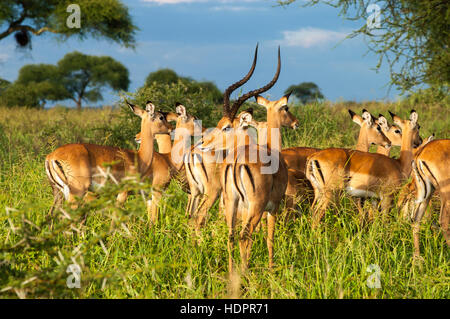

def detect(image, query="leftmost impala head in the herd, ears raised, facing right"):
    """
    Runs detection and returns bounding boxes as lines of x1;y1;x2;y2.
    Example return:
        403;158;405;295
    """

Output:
125;101;172;134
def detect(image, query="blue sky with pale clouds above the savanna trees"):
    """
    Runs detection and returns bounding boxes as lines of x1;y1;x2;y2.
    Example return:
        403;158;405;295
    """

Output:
0;0;398;105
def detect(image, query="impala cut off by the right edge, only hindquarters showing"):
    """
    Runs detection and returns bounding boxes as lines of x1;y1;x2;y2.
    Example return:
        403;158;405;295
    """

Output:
412;139;450;258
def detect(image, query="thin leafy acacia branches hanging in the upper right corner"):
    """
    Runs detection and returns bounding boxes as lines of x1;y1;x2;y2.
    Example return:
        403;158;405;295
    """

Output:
277;0;450;94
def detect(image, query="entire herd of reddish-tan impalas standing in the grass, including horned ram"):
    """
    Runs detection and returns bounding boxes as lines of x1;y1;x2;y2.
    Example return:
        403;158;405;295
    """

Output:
45;46;450;274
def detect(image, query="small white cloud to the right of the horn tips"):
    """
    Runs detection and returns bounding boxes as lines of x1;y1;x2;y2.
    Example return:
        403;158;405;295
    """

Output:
278;27;347;48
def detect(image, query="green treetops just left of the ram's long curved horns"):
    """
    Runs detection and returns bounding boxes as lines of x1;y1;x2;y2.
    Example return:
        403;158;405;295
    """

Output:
145;69;223;103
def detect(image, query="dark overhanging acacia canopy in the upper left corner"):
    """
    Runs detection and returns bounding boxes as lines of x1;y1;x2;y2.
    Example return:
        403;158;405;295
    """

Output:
0;0;137;47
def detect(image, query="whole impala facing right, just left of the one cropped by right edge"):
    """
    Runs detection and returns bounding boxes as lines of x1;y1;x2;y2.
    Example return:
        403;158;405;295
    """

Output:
306;110;422;227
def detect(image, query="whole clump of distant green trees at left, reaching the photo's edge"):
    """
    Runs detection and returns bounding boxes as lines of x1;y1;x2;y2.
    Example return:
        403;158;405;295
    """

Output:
0;52;130;109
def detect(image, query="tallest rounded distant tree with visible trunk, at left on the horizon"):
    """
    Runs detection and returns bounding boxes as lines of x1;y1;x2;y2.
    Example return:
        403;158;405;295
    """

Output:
58;51;130;109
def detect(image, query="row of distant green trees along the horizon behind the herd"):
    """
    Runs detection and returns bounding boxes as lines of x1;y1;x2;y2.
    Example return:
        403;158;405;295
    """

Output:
0;51;324;110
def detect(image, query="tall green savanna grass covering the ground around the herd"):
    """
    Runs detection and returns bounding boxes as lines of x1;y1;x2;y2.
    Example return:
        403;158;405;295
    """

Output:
0;102;450;298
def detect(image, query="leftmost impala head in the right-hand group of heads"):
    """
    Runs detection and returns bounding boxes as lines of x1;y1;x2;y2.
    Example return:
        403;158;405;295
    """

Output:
348;109;391;148
